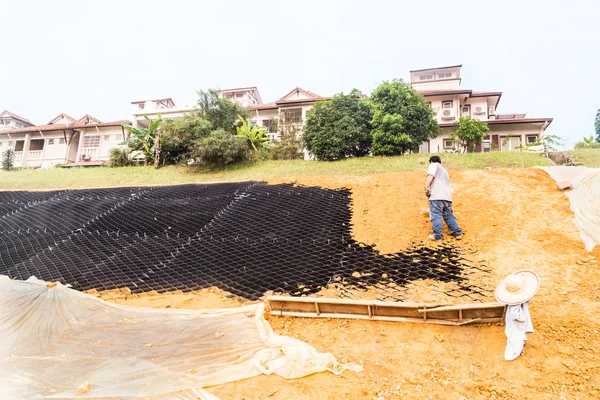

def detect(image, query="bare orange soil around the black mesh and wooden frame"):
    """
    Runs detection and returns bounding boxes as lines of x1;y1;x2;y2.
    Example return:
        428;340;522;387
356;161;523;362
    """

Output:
106;169;600;399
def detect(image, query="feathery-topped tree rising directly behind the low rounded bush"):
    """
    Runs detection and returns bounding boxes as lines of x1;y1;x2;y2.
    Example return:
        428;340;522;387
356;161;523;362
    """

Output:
198;89;250;134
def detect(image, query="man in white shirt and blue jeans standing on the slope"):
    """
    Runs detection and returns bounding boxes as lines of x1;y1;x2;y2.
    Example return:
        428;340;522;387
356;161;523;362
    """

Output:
425;156;462;240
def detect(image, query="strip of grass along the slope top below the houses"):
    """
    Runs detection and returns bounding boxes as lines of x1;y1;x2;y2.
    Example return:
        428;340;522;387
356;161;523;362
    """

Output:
0;152;550;190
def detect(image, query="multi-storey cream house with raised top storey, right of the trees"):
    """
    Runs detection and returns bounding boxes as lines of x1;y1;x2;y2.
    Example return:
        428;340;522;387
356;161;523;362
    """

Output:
410;65;552;153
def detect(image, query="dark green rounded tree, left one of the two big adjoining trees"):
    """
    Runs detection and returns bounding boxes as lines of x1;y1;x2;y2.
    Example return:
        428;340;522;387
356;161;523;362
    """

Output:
302;89;373;161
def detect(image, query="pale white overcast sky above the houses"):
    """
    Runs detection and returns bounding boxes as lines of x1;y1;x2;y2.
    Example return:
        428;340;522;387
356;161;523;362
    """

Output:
0;0;600;148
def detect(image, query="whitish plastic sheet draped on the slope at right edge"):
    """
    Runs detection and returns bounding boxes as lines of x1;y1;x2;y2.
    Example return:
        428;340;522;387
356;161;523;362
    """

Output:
542;167;600;251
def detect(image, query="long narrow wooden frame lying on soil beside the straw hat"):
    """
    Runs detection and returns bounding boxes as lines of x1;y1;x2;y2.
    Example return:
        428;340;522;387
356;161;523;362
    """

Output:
267;296;506;326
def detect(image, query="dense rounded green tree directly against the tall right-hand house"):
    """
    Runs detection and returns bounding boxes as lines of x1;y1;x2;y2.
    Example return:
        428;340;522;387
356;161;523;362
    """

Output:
369;79;440;156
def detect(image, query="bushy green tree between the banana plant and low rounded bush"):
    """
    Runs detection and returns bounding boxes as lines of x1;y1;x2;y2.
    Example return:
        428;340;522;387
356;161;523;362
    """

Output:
160;115;211;164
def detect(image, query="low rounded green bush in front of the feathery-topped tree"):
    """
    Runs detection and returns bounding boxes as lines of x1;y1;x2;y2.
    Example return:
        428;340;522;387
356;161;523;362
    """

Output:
195;129;249;166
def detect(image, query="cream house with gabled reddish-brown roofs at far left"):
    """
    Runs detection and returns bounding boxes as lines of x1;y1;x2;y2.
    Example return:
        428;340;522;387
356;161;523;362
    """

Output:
0;113;131;168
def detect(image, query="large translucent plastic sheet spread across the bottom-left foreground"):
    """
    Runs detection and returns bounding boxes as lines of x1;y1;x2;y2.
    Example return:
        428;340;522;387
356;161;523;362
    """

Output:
0;276;362;399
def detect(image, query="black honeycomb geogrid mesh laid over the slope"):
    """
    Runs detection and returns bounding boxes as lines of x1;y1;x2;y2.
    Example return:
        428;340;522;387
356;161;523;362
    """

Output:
0;182;489;301
